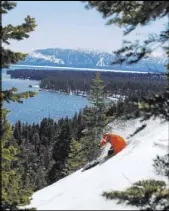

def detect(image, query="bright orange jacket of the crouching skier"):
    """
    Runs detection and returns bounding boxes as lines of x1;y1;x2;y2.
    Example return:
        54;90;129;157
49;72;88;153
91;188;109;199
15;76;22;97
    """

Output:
100;134;127;154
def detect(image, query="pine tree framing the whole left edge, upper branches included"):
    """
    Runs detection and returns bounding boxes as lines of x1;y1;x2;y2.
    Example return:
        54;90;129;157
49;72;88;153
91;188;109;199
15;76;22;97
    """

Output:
0;1;36;209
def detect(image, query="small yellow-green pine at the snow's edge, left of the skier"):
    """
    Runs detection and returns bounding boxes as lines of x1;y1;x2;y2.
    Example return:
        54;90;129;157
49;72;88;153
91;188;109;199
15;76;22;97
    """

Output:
63;139;85;176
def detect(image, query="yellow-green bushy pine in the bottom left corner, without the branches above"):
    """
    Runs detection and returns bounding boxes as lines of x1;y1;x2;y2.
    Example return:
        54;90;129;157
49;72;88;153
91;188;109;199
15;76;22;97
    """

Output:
1;110;33;209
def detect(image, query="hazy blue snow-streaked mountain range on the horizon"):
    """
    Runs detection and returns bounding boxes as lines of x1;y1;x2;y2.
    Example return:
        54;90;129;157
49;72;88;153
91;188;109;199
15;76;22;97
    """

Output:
18;48;167;72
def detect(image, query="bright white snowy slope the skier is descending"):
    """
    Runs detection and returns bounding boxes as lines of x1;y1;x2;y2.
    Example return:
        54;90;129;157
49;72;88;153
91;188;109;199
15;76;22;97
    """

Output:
24;119;169;210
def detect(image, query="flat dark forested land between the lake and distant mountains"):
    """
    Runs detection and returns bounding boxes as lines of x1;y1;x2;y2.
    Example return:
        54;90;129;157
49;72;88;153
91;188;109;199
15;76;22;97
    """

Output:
7;69;167;98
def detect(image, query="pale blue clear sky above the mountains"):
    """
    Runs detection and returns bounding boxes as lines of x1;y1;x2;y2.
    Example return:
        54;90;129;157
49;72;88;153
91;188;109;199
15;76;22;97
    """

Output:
2;1;167;55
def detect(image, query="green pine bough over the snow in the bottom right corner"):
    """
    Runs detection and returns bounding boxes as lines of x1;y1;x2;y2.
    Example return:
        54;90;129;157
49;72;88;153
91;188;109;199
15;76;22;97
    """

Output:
103;180;169;211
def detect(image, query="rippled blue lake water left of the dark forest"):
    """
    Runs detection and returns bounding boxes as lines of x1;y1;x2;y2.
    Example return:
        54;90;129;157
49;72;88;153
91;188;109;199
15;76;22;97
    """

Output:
2;71;89;124
